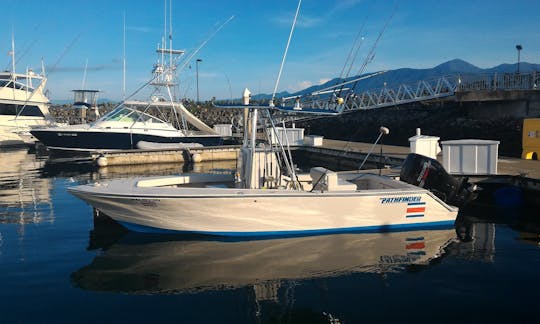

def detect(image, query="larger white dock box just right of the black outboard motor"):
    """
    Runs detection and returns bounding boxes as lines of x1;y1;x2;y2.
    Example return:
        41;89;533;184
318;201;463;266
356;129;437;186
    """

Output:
441;139;499;175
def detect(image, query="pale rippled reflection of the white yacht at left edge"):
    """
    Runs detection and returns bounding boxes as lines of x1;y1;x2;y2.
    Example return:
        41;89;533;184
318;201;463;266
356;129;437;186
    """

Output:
0;148;54;224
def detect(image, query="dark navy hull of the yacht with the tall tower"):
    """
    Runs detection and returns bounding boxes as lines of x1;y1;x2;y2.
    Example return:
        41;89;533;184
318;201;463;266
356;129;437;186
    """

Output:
31;129;223;151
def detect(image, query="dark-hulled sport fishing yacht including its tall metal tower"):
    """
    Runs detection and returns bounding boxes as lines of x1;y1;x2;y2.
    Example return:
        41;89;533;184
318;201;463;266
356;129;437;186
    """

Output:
32;26;223;152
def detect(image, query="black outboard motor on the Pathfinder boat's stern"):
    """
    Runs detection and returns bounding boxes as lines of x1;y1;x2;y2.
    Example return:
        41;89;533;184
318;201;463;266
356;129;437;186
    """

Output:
399;153;477;207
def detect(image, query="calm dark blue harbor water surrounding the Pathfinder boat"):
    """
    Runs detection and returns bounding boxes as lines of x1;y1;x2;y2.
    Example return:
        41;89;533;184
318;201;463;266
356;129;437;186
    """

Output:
0;150;540;323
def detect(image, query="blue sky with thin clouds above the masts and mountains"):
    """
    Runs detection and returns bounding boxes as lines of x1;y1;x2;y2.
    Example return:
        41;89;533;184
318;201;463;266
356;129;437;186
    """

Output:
0;0;540;100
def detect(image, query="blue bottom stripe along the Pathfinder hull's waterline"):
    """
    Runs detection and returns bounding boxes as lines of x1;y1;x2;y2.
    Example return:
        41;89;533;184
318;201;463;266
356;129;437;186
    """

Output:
118;220;454;237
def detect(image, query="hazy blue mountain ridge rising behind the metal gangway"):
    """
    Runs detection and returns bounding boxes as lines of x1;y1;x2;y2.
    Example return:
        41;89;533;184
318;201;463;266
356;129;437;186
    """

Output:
252;59;540;100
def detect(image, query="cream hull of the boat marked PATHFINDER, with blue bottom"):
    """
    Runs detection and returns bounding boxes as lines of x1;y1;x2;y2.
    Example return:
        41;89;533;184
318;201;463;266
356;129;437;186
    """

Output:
70;182;458;236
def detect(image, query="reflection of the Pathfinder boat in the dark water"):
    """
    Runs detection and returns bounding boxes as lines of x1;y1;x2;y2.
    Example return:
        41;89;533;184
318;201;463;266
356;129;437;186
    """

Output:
72;216;456;299
